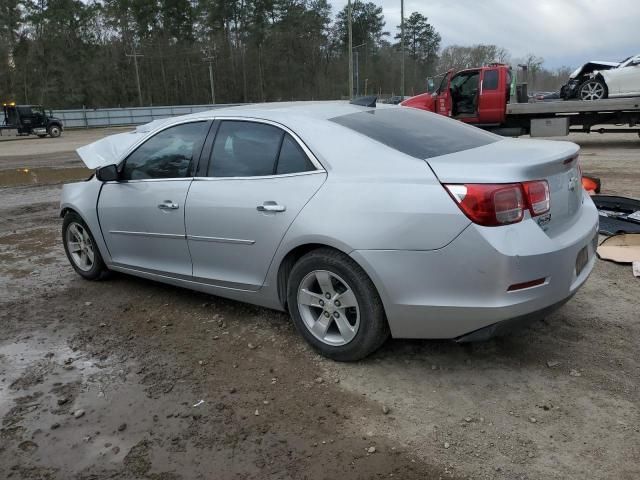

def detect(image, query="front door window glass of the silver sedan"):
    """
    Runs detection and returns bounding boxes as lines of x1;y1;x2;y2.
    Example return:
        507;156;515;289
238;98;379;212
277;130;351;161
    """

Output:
122;122;207;180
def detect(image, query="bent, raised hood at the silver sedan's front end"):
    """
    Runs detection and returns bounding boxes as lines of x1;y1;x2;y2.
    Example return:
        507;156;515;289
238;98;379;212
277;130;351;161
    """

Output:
76;119;167;169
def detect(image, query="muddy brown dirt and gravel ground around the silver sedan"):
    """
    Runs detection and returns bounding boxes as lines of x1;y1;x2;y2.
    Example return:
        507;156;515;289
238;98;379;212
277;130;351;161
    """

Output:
0;130;640;480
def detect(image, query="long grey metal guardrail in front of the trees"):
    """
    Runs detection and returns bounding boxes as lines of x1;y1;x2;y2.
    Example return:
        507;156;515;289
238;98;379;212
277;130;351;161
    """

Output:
53;103;242;128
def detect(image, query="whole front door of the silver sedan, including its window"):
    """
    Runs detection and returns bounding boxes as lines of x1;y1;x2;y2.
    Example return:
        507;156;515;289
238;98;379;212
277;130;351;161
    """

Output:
98;121;210;278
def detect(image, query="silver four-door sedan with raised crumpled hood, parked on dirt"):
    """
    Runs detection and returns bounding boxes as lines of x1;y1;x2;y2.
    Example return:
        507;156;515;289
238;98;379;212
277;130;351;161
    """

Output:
61;102;598;361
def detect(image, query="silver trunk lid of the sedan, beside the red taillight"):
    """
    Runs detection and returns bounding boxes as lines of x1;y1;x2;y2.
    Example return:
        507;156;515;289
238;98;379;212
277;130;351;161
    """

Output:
426;139;583;235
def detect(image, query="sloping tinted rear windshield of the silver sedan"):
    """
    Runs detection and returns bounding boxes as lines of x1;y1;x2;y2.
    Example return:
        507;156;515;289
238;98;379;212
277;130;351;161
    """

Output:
331;107;500;159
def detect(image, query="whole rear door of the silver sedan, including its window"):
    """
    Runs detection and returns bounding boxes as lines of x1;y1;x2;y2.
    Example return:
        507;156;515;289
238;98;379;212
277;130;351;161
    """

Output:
185;119;326;290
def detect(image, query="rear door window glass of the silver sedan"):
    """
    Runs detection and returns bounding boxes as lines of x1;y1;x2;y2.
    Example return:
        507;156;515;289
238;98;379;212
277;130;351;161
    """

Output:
208;120;313;177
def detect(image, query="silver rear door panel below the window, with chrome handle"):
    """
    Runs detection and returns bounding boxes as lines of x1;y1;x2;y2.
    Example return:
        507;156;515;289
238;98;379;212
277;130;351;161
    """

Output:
185;172;326;290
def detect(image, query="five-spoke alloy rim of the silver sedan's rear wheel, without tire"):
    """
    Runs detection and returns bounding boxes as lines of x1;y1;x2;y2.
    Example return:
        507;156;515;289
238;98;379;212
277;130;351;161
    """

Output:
297;270;360;346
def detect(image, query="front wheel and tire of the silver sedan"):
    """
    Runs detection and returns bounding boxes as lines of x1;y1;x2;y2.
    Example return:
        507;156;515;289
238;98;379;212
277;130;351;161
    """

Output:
62;212;109;280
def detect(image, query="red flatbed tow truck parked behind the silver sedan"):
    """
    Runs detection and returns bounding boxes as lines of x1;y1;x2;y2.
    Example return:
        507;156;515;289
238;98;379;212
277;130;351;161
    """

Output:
400;64;640;136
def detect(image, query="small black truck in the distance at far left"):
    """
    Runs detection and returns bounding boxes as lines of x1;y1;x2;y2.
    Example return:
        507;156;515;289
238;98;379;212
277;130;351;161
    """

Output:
0;102;64;138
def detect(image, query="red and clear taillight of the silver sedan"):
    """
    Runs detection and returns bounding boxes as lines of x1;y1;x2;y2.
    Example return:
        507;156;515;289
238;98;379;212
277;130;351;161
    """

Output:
445;180;551;227
